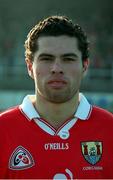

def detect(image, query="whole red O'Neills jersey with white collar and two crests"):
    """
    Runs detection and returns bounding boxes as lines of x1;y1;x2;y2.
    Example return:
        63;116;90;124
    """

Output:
0;95;113;179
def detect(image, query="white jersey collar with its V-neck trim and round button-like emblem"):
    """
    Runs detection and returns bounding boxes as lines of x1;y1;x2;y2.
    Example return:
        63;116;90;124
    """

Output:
20;94;91;139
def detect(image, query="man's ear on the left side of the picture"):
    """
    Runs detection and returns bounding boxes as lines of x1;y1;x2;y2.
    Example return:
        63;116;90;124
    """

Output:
25;59;34;79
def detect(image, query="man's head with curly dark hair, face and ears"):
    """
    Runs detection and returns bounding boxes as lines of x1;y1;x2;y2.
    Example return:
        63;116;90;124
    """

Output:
25;16;89;103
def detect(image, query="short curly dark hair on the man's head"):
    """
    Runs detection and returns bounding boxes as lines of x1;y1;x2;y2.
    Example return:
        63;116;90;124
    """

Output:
25;16;89;61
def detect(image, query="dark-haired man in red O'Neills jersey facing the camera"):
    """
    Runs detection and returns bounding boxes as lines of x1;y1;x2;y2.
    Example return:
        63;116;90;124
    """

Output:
0;16;113;179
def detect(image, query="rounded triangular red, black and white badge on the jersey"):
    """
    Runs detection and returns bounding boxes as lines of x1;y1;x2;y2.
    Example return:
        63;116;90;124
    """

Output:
9;146;34;170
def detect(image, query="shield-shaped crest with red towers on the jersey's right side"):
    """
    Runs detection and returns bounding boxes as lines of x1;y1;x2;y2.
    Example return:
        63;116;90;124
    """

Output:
81;141;102;165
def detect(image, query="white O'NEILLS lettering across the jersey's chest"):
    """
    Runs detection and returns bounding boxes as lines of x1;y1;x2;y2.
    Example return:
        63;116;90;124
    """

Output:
44;143;69;150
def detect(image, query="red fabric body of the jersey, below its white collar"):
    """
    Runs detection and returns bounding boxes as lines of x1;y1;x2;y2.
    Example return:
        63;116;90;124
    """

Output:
0;107;113;179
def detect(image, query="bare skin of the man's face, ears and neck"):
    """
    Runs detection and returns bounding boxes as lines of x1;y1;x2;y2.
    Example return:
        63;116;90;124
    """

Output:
26;36;89;129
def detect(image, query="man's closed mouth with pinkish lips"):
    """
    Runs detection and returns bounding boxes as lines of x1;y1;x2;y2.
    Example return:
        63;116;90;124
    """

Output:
48;79;67;89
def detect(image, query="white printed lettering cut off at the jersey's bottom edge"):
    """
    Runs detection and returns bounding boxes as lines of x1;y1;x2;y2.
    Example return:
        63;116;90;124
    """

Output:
53;169;73;180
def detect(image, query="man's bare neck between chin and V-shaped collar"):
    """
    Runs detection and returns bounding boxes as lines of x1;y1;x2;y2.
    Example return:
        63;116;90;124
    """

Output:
35;92;79;129
